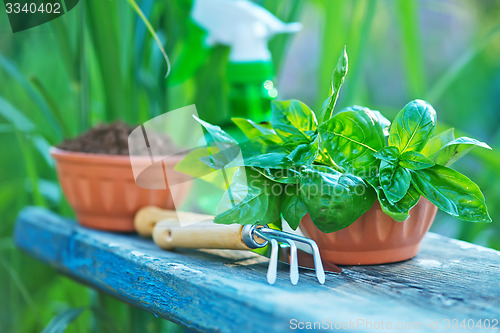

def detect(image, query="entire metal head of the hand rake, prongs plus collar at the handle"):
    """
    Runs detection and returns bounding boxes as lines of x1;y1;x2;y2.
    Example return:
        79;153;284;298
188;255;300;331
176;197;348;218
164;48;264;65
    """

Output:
242;224;325;285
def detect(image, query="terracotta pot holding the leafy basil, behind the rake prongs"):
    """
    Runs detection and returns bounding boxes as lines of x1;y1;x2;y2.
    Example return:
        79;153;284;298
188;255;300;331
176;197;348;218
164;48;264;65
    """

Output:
300;197;437;265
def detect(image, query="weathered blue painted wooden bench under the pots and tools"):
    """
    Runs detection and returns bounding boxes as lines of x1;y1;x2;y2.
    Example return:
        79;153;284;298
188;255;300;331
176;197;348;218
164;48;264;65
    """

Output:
14;207;500;332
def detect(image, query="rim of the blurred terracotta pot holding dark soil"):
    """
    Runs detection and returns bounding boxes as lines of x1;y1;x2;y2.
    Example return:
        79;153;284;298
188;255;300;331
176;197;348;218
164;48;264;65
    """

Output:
49;147;186;165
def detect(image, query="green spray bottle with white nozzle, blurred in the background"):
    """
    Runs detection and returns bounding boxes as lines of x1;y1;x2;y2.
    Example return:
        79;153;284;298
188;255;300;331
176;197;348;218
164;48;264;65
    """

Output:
174;0;302;130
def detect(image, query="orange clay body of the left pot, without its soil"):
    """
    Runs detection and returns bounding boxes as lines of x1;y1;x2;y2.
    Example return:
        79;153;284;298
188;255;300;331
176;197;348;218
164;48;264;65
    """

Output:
50;148;190;232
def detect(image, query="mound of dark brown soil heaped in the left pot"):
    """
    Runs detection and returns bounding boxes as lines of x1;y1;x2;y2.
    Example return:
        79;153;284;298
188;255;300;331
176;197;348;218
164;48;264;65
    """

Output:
57;121;172;155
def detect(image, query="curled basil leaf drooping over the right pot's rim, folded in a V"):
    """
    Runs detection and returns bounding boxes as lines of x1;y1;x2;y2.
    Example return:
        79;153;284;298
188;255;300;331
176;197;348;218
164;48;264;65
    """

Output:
368;178;420;222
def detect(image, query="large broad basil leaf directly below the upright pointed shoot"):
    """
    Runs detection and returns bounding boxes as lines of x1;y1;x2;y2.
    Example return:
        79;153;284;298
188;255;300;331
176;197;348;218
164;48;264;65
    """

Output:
319;110;385;175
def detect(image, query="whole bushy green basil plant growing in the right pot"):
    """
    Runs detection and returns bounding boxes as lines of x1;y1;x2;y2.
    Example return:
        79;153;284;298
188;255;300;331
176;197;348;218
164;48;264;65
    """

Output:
189;49;491;233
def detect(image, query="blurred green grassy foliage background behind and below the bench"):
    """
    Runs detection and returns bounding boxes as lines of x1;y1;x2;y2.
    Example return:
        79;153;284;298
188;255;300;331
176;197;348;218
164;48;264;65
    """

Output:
0;0;500;332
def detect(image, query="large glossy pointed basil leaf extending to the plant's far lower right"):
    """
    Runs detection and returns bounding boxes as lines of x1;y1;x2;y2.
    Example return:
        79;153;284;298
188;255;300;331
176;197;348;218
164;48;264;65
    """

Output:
412;165;491;222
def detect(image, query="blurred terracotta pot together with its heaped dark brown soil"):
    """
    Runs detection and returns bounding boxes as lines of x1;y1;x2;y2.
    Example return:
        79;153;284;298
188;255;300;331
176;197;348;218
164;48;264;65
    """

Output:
51;122;189;232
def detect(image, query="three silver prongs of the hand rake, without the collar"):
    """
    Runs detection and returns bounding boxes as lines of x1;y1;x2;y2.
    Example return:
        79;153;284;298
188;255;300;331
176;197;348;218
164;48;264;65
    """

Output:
253;227;325;284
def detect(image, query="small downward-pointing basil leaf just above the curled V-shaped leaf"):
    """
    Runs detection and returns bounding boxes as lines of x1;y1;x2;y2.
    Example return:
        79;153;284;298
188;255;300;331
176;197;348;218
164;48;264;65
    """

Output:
379;161;411;203
